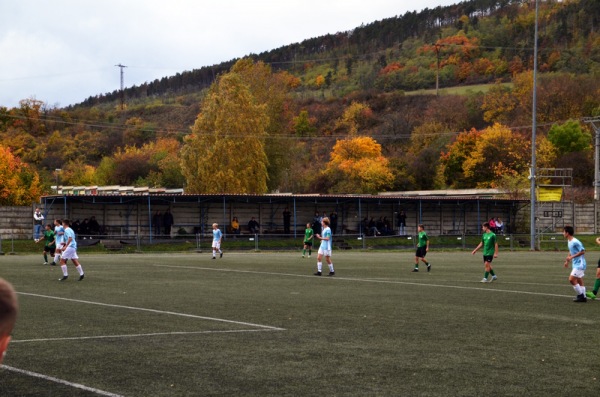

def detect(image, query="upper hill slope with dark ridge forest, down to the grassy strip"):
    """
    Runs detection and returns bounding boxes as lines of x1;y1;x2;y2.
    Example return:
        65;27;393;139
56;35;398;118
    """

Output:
75;0;600;106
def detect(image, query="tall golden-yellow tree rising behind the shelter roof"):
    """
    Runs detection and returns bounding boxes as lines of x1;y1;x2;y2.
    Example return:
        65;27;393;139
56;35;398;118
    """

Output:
181;73;269;194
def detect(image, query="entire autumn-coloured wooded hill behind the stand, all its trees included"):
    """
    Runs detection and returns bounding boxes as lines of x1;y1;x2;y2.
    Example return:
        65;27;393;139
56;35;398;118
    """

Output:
0;0;600;205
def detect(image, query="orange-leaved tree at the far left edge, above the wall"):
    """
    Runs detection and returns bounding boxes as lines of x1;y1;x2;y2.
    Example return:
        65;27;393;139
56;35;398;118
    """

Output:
0;145;44;205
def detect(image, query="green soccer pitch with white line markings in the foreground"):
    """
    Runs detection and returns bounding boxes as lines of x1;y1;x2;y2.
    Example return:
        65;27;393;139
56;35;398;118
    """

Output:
0;252;600;396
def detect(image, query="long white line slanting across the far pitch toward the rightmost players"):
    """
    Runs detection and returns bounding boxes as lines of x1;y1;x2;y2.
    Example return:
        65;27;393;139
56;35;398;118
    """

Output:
151;265;572;298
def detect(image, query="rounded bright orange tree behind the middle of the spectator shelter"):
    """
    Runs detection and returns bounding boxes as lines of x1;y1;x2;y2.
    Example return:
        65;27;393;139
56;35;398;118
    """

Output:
325;136;394;193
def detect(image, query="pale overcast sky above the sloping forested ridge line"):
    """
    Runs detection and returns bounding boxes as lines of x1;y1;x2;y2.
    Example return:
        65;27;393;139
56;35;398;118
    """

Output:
0;0;459;107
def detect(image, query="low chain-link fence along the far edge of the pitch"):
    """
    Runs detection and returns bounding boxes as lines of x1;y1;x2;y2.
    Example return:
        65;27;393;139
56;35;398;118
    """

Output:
0;233;596;255
